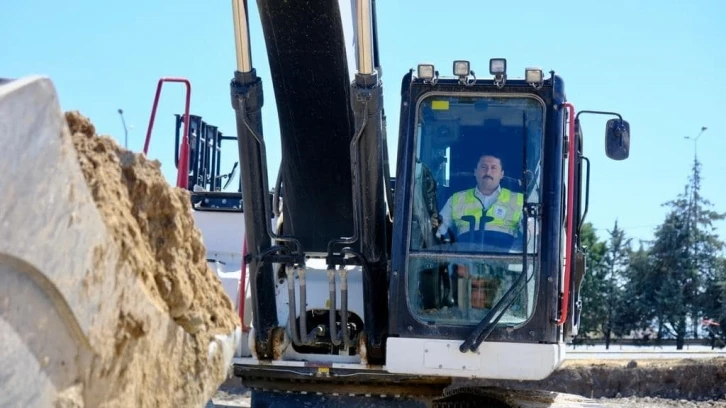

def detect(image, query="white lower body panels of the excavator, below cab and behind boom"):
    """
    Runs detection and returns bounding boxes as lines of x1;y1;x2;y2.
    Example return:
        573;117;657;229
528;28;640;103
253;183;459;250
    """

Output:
194;210;565;380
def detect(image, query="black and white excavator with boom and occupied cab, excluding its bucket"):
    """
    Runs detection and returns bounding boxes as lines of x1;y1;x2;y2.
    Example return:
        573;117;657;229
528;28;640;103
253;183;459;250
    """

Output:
0;0;630;408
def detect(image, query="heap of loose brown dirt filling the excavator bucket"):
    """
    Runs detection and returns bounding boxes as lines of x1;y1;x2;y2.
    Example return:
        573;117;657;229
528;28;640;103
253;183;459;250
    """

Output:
66;112;239;333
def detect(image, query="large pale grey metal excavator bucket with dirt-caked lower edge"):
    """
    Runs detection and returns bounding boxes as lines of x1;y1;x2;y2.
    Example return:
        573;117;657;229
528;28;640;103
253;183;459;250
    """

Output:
0;77;239;407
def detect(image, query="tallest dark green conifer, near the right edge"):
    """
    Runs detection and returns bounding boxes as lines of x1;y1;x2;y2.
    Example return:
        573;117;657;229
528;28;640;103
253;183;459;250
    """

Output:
620;155;726;349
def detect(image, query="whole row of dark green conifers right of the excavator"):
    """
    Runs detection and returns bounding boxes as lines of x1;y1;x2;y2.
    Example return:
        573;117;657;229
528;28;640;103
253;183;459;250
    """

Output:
573;159;726;350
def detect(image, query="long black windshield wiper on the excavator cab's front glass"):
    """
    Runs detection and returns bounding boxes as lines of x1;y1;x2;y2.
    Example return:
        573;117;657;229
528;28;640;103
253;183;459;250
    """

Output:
459;110;538;353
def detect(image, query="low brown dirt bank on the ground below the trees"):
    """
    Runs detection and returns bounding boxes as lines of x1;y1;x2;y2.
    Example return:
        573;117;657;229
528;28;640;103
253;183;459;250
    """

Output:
462;358;726;401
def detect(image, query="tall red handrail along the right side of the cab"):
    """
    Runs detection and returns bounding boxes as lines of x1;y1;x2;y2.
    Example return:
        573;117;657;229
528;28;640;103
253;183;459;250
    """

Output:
557;102;575;325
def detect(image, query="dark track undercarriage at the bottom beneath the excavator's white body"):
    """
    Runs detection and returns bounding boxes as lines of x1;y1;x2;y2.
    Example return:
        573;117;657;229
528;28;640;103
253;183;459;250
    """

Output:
235;366;602;408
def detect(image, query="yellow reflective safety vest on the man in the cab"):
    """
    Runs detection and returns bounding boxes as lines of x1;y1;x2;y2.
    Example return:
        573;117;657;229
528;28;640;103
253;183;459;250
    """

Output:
451;187;524;237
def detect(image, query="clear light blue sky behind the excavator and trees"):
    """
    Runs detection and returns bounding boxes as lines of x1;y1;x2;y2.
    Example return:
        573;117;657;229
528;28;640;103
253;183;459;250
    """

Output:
0;0;726;247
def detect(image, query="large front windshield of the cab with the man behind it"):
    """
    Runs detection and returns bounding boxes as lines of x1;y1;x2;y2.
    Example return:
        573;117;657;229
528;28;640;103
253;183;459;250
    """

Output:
407;94;545;325
